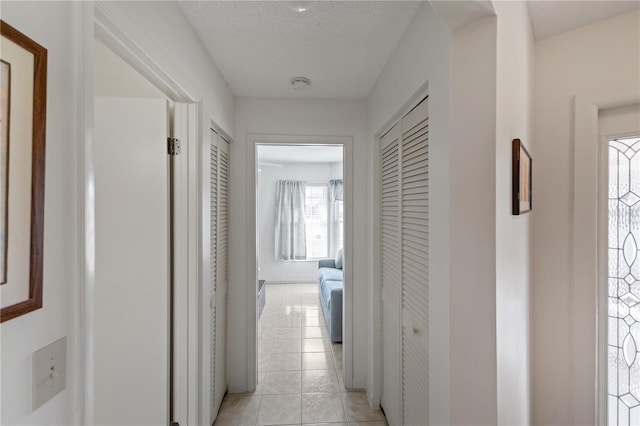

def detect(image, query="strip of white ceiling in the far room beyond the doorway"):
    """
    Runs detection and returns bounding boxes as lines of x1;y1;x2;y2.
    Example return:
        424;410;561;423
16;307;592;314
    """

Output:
258;145;342;165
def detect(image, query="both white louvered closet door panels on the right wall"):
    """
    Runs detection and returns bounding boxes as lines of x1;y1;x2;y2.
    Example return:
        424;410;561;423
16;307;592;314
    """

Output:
380;99;429;426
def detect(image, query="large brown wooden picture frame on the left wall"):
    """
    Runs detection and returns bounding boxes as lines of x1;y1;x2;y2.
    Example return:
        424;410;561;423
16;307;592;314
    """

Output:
0;20;47;322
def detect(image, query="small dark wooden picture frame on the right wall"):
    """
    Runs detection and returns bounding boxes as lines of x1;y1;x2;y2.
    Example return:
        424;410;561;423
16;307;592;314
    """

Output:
511;139;533;215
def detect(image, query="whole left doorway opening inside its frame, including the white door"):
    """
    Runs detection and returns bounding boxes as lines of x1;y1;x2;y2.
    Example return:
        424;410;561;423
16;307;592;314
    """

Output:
85;37;197;424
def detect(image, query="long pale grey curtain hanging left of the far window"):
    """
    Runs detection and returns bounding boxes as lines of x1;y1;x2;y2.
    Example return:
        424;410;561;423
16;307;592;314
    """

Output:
275;180;307;260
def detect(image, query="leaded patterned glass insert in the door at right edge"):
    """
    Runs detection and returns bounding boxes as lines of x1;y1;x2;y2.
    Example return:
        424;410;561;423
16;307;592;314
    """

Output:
607;138;640;426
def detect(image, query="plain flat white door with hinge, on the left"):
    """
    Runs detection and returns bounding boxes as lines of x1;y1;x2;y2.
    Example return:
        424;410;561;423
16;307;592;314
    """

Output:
94;97;170;425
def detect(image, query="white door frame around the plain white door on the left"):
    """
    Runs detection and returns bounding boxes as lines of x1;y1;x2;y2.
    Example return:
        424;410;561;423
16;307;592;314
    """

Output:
75;1;202;426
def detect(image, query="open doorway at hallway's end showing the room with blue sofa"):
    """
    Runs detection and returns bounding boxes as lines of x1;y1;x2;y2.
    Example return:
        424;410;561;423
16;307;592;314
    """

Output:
254;141;351;394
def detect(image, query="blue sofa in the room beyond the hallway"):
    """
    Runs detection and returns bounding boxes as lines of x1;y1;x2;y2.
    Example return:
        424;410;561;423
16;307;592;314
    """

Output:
318;254;343;342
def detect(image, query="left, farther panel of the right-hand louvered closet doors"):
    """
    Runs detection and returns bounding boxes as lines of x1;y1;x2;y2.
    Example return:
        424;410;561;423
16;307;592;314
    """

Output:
380;124;402;426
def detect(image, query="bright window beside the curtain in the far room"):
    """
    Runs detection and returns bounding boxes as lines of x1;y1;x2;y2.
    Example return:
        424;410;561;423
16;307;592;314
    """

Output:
304;184;329;259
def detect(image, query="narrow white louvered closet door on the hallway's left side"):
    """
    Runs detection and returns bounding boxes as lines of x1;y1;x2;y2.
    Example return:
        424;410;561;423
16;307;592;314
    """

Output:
209;131;229;419
